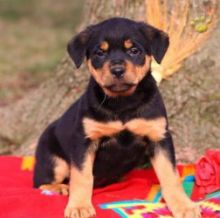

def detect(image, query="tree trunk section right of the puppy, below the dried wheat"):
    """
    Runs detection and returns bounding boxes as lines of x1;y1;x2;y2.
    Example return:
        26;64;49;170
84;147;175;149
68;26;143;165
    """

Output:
160;22;220;161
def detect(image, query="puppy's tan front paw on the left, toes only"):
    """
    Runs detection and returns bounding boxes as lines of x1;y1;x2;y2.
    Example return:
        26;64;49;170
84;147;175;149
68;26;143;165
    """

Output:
64;204;96;218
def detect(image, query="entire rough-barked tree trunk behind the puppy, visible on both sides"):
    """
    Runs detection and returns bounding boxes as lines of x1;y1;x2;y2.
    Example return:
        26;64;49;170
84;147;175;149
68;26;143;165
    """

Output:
0;0;220;161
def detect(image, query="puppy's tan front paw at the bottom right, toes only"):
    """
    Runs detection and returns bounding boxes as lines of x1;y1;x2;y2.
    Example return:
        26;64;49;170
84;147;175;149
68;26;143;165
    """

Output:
171;201;201;218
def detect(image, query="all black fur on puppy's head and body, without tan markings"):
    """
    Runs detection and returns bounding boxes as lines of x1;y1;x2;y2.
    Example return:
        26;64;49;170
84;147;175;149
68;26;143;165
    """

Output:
34;18;175;187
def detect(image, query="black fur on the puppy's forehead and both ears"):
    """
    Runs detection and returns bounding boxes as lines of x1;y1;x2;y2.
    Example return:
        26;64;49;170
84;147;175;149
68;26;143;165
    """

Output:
67;18;169;68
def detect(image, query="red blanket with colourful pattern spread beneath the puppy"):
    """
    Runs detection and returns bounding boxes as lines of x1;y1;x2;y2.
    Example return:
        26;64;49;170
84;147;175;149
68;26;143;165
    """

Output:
0;157;220;218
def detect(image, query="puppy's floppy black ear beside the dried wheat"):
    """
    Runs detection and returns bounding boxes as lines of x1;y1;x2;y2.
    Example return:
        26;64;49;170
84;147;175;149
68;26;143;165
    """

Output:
140;22;169;64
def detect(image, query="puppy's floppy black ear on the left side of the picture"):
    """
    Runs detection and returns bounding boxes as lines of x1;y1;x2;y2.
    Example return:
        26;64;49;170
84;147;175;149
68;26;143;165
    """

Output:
67;27;92;68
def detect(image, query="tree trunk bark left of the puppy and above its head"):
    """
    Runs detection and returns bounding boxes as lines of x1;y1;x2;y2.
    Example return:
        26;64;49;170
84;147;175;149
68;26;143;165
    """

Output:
0;0;145;154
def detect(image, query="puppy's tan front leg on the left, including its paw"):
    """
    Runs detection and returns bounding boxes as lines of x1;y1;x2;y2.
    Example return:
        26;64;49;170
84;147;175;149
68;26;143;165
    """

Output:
64;151;95;218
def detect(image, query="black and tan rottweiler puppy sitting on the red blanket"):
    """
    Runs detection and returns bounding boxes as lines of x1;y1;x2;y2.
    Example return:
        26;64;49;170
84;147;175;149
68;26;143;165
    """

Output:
34;18;200;218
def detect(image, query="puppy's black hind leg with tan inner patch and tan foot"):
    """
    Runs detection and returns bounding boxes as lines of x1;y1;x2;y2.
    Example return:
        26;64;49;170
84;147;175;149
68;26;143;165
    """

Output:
34;123;69;195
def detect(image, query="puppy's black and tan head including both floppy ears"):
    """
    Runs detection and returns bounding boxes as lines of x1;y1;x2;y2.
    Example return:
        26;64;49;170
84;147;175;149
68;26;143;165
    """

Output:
67;18;169;97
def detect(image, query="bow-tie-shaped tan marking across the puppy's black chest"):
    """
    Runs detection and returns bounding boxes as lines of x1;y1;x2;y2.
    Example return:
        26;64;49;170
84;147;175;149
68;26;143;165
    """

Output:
83;117;166;142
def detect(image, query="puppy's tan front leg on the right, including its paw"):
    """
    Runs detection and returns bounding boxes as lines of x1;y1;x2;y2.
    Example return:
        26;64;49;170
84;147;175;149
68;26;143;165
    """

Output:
151;149;200;218
